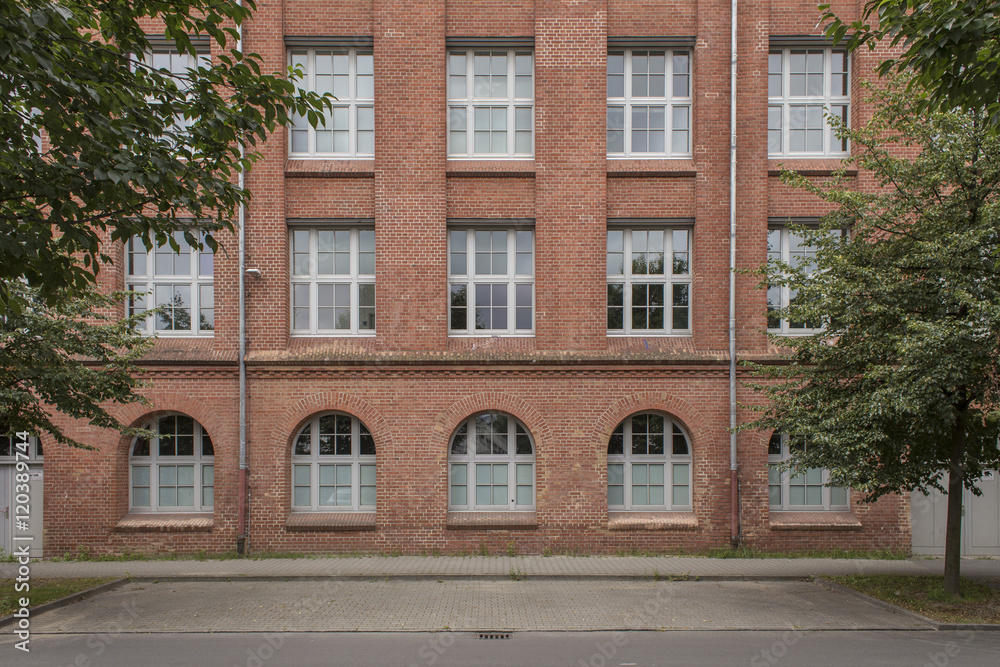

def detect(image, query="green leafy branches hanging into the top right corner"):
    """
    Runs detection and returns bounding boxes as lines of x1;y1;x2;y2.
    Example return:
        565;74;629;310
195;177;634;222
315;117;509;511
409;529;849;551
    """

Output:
820;0;1000;125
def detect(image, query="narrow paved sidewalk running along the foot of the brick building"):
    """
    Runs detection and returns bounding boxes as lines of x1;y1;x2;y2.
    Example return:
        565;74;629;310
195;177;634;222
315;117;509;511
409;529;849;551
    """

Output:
0;556;1000;584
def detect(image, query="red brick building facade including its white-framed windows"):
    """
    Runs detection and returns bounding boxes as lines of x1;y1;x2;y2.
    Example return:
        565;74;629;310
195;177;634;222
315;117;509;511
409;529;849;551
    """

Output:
45;0;910;556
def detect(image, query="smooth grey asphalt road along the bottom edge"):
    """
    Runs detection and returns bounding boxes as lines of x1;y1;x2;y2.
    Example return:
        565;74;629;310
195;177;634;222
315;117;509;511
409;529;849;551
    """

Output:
0;631;1000;667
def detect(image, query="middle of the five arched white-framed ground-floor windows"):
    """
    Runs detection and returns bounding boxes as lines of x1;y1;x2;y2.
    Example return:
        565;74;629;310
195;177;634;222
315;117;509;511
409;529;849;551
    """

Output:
448;412;535;512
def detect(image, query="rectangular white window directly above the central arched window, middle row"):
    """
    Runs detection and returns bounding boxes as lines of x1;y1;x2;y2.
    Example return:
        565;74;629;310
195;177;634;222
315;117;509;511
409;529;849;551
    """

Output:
448;227;535;335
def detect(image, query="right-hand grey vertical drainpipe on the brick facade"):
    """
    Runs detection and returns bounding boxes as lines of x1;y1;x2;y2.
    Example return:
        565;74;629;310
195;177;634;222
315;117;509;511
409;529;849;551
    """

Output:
729;0;740;549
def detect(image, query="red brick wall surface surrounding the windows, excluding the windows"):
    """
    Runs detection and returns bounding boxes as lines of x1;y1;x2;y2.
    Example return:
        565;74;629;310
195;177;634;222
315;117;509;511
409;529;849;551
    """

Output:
45;0;910;556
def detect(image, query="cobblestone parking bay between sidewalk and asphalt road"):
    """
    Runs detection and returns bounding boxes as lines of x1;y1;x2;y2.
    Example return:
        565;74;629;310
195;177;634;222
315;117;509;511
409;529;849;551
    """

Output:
31;579;929;634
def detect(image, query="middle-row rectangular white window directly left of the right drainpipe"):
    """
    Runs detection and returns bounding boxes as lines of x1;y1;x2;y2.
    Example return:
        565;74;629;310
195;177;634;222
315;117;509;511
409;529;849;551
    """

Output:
607;227;691;335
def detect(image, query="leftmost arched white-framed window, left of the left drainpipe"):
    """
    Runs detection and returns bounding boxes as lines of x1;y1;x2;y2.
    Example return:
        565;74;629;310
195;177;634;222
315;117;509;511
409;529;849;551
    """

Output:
129;414;215;512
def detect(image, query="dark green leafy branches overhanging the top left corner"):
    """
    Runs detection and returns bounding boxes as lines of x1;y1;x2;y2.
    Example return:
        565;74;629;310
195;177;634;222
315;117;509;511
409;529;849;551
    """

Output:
0;0;330;315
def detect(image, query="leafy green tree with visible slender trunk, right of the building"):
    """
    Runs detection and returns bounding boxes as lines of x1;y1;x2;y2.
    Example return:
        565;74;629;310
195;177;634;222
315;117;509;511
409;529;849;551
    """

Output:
747;81;1000;594
